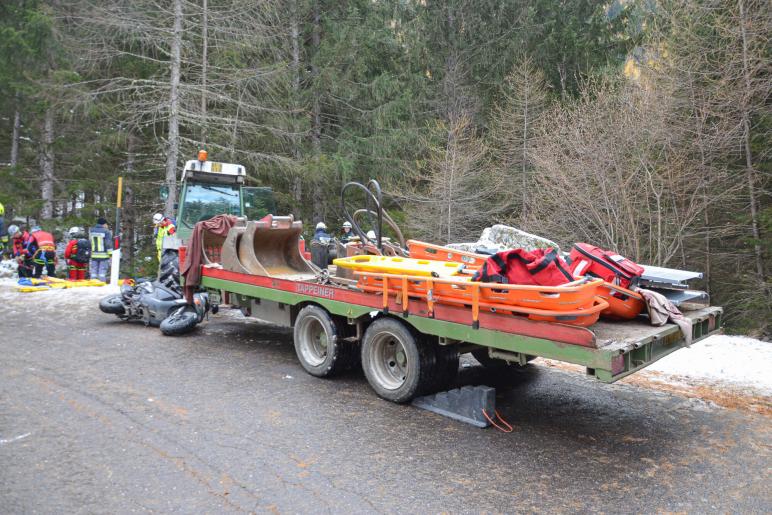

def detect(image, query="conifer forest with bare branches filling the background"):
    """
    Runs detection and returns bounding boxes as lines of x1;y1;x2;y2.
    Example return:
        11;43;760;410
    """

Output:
0;0;772;336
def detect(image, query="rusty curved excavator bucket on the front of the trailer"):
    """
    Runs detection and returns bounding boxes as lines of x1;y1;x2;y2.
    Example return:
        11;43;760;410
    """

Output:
222;215;316;280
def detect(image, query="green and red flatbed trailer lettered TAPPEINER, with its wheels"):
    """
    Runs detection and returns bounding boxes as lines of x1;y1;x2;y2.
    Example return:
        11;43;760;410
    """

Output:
201;266;723;402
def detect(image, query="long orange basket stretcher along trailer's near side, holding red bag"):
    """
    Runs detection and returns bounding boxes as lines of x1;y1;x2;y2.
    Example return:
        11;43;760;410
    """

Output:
354;271;609;327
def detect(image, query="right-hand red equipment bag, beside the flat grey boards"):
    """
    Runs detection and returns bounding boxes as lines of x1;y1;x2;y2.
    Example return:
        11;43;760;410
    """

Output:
568;243;644;288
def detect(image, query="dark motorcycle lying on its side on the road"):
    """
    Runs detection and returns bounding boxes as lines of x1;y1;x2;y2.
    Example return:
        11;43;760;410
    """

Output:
99;281;211;336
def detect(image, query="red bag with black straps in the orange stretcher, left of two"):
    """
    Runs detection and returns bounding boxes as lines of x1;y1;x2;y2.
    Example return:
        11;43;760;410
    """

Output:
472;248;574;286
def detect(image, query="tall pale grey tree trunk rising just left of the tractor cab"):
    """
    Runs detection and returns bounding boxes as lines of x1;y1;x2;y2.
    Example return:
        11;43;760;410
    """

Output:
164;0;182;215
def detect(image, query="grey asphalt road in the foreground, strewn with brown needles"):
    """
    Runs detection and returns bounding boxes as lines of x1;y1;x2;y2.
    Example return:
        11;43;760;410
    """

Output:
0;294;772;513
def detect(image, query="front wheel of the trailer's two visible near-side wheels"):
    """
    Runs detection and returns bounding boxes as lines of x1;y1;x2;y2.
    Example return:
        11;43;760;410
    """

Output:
293;306;359;377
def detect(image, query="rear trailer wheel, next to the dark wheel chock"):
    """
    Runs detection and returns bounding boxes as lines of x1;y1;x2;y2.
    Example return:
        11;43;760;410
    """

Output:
362;318;436;403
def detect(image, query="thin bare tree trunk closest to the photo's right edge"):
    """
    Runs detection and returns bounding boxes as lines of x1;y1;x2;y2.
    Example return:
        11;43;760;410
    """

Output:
737;0;764;285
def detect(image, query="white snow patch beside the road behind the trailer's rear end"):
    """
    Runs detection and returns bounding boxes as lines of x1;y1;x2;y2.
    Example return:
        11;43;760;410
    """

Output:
644;335;772;396
